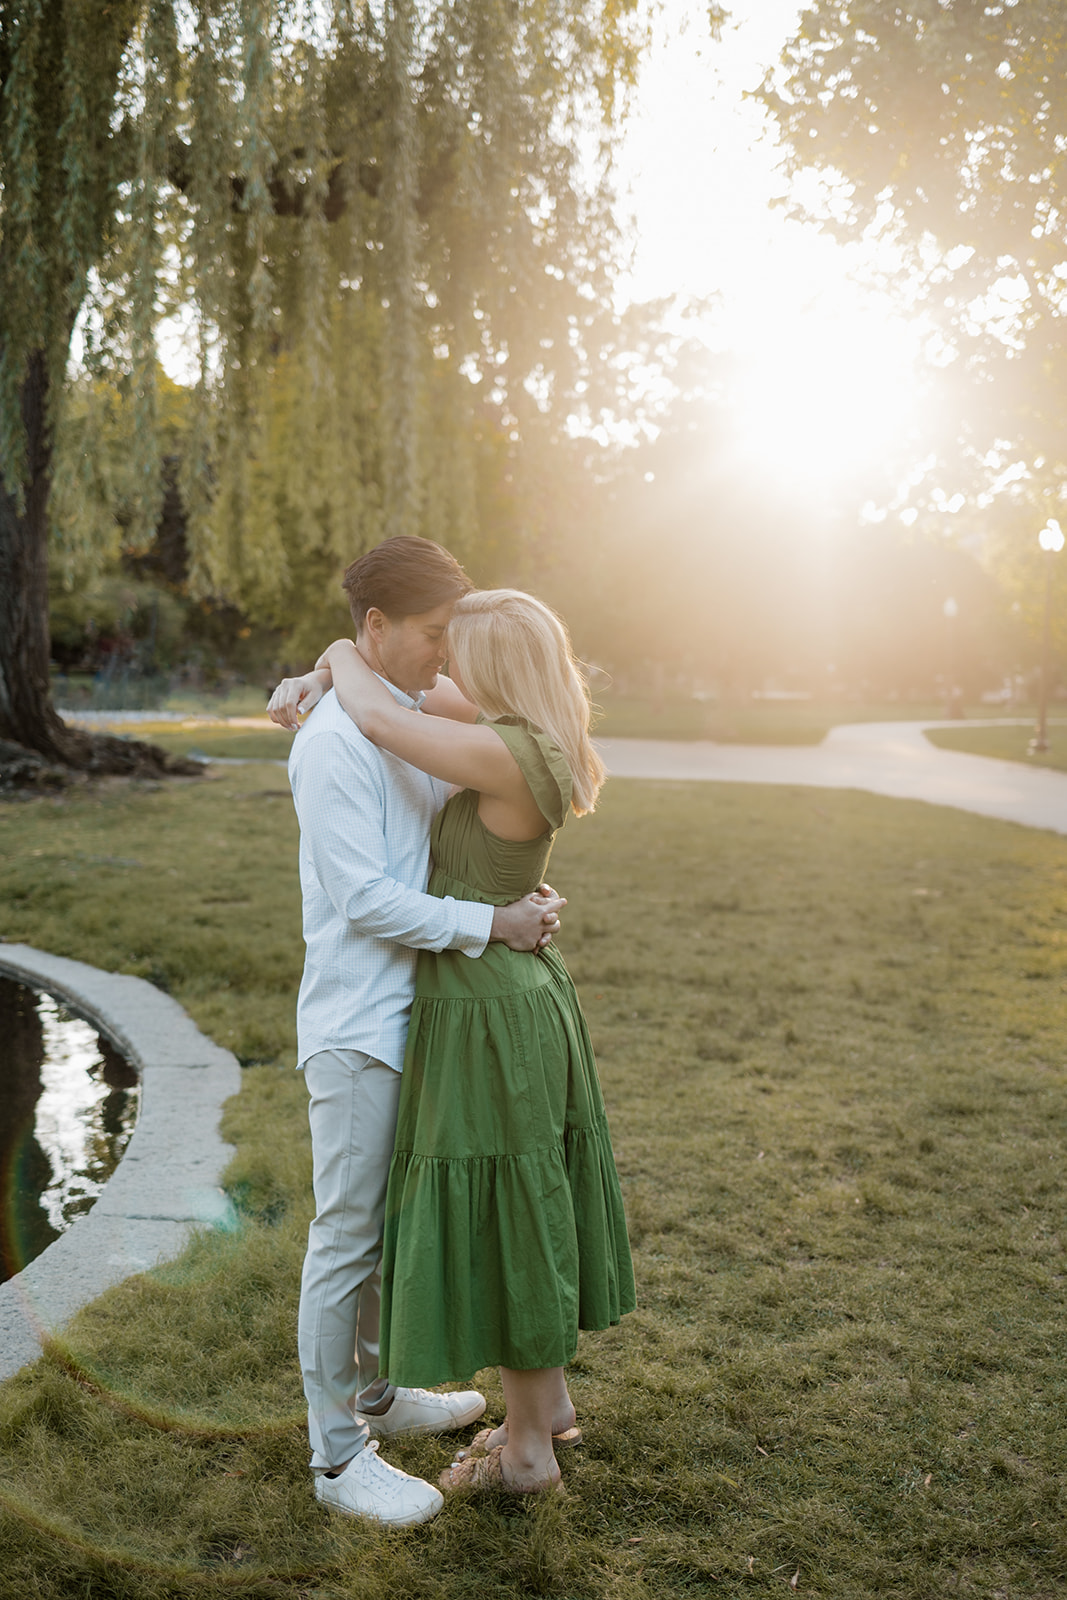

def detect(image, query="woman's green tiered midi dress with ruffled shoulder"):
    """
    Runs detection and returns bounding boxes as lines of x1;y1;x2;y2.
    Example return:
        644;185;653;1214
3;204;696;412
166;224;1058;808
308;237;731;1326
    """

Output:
381;718;635;1384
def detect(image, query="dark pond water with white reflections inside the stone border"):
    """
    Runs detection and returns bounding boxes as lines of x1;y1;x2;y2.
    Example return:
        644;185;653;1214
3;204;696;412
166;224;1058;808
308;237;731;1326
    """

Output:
0;978;141;1282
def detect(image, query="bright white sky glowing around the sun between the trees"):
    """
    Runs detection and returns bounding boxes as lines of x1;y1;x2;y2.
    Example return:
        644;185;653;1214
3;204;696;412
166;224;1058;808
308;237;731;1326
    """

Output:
616;0;918;496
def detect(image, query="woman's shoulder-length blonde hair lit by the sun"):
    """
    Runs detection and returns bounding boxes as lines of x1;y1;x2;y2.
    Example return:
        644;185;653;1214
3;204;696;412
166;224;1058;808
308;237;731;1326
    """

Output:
448;589;605;816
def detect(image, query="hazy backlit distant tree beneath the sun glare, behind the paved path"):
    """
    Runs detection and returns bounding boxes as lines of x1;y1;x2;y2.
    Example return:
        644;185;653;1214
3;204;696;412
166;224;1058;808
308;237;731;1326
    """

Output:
549;380;1011;701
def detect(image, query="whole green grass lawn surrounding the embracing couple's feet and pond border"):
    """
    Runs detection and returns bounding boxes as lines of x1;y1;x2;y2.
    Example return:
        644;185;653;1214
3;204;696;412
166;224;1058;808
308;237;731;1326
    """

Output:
0;765;1067;1600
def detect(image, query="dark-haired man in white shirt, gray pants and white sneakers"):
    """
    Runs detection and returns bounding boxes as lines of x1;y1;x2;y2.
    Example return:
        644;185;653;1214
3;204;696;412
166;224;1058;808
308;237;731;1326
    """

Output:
270;538;563;1526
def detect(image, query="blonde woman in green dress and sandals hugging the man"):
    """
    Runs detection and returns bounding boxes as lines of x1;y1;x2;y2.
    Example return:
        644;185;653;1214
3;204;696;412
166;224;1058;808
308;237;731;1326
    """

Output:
279;589;635;1493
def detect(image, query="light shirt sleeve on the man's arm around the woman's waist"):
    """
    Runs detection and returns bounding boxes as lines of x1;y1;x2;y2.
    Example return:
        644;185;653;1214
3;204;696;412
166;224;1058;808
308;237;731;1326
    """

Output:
291;733;493;957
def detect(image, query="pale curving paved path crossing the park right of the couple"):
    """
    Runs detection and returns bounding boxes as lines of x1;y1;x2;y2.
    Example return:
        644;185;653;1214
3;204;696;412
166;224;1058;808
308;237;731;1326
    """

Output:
597;718;1067;834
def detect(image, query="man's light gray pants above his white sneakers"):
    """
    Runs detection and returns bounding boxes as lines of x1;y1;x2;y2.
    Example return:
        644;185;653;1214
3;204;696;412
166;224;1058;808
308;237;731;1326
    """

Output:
299;1050;400;1467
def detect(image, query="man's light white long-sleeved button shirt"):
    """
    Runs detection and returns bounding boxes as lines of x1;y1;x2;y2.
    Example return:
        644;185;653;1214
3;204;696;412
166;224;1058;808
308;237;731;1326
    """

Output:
290;680;493;1072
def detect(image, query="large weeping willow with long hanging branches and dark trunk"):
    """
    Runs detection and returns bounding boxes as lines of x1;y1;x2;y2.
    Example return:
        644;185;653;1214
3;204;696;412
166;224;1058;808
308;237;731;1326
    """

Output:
0;0;641;770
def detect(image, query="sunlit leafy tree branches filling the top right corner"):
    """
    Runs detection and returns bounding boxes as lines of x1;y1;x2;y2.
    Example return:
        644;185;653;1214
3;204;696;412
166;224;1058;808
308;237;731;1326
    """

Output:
761;0;1067;656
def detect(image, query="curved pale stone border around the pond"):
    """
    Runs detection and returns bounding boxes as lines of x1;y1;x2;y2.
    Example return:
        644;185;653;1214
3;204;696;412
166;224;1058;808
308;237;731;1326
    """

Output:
0;944;240;1379
